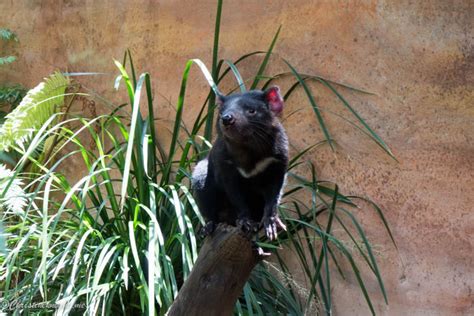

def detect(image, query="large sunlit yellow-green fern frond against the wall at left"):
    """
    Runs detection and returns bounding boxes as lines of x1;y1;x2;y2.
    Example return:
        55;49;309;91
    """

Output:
0;72;69;151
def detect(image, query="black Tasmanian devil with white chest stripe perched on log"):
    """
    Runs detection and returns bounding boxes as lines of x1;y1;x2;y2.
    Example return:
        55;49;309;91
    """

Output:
192;87;288;239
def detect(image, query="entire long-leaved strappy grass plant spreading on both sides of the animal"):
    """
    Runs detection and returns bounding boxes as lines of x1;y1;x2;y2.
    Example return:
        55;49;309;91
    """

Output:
0;1;391;315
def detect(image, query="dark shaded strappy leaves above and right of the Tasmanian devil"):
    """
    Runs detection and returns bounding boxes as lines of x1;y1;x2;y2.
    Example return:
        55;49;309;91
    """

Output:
181;0;396;315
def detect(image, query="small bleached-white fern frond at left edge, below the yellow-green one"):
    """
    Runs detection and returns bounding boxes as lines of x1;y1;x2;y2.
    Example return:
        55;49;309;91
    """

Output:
0;165;27;215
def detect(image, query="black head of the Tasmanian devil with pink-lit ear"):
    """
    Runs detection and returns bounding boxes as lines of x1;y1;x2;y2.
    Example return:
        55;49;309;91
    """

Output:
218;86;283;142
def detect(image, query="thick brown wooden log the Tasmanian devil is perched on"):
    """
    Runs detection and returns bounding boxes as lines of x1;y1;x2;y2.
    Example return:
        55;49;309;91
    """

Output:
167;224;262;316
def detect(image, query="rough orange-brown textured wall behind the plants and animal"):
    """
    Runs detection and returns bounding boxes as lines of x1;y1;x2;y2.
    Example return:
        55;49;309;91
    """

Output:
0;0;474;315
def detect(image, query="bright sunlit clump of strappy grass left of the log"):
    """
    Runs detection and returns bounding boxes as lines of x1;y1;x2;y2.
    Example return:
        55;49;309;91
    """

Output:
0;60;206;314
